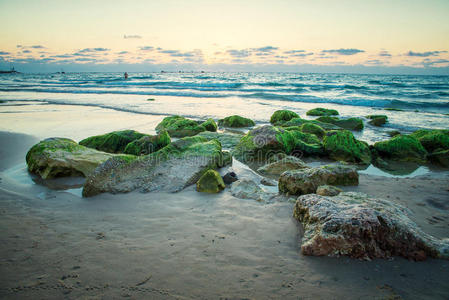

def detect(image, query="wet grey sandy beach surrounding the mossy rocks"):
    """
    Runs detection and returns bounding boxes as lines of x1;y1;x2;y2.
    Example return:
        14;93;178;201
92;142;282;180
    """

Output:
0;105;449;299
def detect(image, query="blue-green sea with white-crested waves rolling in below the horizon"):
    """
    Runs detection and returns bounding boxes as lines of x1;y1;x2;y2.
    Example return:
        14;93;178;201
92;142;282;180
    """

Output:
0;72;449;141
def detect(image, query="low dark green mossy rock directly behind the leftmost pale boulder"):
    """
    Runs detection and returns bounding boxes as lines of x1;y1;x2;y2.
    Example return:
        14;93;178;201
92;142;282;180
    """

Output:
79;130;146;153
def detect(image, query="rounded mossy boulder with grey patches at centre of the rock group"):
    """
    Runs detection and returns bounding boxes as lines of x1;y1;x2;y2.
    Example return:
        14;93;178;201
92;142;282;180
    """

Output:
233;125;295;162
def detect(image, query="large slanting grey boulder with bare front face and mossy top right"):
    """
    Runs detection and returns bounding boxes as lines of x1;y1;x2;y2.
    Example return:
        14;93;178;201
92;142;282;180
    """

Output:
83;136;224;197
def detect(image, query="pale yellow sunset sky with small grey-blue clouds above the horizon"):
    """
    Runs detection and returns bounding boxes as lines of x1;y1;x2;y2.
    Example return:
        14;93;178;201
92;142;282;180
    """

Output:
0;0;449;75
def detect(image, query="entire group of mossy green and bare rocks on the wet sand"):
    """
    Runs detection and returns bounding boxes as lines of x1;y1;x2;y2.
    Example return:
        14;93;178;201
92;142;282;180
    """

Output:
26;108;449;259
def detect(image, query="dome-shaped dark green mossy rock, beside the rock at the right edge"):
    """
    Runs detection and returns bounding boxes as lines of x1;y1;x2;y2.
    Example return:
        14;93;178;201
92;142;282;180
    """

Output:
373;135;427;163
